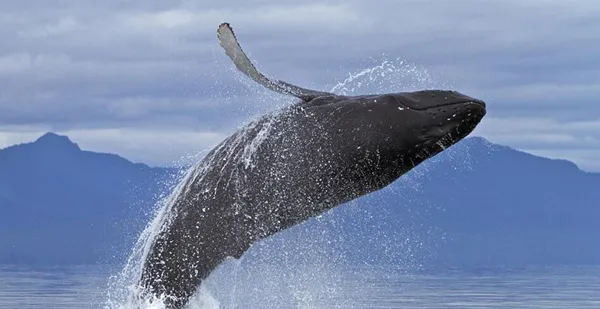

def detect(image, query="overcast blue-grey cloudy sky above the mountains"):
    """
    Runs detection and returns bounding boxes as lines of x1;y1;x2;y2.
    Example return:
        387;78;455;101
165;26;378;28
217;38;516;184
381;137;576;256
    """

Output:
0;0;600;171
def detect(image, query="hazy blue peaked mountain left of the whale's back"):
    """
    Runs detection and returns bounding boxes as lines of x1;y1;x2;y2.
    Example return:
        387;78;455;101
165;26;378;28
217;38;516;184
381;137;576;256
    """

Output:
0;133;178;264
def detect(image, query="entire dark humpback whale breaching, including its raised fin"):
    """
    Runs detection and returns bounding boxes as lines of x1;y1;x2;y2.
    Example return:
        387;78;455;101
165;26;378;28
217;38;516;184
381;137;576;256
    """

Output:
139;23;486;308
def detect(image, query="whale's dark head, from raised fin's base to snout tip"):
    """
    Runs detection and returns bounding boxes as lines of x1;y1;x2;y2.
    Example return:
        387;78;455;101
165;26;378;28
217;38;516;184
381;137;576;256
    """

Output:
310;90;486;181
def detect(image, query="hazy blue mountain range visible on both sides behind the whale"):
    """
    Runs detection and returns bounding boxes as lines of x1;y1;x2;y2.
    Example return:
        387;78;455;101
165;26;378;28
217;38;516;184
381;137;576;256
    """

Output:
0;133;600;266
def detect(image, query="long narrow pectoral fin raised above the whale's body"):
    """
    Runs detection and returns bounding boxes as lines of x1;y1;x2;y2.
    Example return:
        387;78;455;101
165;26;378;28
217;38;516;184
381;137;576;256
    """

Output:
217;23;334;101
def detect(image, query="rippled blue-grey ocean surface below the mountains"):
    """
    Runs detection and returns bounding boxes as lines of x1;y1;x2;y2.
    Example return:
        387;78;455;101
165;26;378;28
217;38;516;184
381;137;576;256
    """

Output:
0;266;600;309
